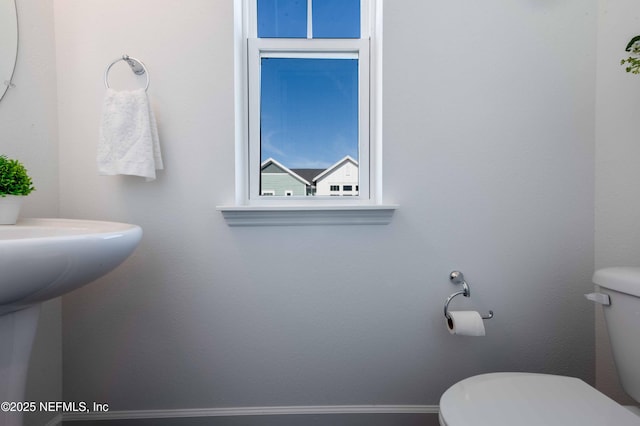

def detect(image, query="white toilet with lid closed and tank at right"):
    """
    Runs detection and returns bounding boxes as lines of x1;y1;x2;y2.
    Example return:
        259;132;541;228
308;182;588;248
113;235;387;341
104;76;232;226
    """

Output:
439;267;640;426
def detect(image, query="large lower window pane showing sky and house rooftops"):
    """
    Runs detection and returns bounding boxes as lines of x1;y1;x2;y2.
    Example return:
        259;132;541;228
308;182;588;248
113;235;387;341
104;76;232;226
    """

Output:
260;58;358;195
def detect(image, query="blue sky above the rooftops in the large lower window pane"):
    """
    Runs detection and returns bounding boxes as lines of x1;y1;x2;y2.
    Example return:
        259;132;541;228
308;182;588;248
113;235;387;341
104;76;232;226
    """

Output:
261;58;358;168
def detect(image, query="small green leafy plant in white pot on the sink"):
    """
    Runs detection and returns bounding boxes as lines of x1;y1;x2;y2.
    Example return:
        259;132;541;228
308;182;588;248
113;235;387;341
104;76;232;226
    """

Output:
0;155;35;225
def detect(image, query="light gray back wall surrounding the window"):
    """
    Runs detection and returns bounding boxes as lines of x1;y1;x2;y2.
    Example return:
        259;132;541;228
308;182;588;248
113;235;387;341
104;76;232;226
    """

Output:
54;0;597;422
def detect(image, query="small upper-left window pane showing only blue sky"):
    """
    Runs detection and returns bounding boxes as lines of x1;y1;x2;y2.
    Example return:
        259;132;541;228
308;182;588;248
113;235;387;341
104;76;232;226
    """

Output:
258;0;307;38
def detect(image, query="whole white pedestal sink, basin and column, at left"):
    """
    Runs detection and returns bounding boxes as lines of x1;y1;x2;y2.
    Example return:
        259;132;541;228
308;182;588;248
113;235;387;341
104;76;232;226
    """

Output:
0;219;142;426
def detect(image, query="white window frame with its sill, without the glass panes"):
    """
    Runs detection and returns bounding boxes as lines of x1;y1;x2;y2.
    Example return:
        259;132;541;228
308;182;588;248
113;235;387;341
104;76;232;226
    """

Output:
218;0;397;225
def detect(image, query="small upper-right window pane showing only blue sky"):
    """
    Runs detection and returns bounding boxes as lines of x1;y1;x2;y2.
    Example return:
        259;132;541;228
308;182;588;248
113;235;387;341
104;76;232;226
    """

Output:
312;0;360;38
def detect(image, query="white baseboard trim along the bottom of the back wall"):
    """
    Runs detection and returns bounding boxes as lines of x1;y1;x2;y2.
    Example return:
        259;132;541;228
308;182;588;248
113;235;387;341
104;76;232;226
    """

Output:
62;405;439;426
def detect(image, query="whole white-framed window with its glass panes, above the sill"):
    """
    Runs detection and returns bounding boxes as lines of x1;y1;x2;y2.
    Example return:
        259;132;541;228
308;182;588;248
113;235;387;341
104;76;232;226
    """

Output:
235;0;381;205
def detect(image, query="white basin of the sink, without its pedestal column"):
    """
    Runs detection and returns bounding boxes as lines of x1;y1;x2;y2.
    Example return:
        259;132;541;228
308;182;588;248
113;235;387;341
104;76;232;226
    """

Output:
0;219;142;315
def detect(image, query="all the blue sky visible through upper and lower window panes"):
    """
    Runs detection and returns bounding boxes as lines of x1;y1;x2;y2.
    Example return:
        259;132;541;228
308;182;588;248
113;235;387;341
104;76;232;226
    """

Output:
258;0;360;168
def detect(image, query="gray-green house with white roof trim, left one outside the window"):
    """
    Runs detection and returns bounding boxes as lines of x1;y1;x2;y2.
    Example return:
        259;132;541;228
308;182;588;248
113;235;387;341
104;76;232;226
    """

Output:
260;158;311;197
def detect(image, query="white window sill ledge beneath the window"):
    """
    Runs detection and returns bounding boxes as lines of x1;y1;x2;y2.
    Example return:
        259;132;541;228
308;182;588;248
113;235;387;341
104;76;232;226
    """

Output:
217;204;398;226
